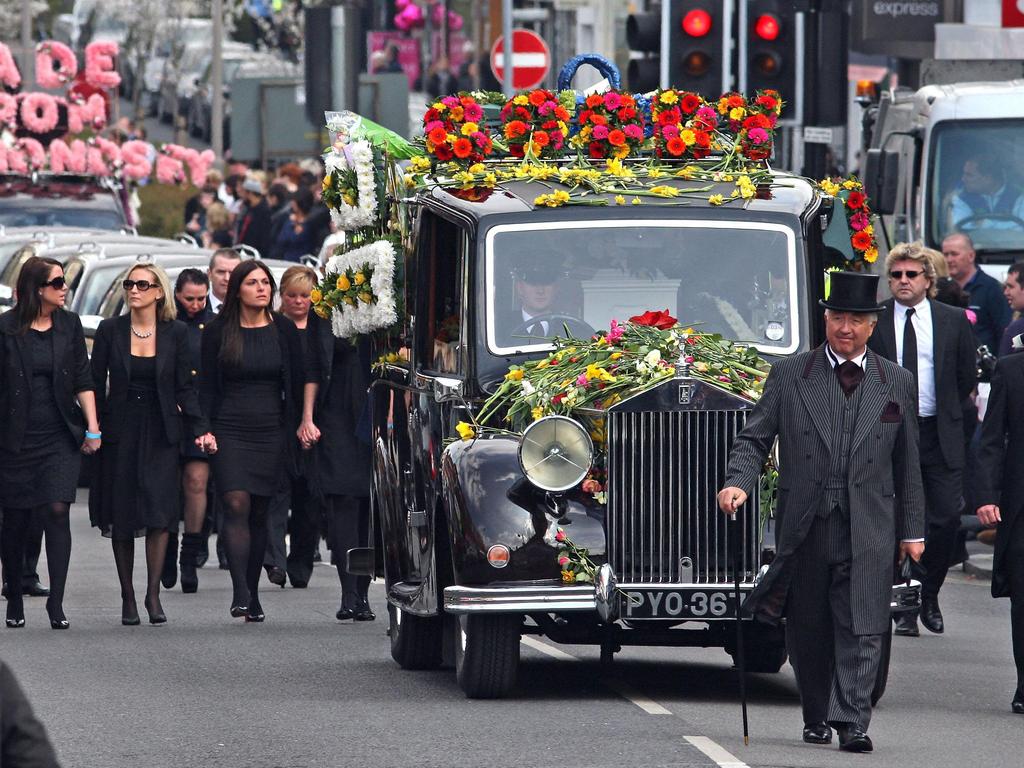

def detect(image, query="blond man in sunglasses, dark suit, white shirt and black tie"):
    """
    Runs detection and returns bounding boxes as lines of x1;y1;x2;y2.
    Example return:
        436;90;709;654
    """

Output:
867;243;976;637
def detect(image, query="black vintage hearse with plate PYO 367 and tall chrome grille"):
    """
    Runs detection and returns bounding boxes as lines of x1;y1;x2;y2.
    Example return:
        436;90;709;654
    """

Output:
362;171;913;697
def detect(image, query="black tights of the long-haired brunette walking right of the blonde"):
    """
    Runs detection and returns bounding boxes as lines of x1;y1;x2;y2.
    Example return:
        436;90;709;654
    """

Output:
221;490;270;613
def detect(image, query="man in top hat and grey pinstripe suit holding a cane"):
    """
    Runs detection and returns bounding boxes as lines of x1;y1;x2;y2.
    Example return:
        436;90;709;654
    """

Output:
718;272;925;752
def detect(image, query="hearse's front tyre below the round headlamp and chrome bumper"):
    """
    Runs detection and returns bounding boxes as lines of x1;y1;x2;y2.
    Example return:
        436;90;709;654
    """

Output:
452;614;522;698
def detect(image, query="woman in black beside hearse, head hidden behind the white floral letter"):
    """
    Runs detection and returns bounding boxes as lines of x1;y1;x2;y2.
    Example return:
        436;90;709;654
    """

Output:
298;313;376;622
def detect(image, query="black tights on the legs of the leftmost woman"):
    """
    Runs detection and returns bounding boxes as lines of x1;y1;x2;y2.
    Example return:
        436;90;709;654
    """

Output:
0;502;71;618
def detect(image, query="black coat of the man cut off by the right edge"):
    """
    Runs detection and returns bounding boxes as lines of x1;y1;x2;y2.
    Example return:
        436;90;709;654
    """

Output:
976;354;1024;597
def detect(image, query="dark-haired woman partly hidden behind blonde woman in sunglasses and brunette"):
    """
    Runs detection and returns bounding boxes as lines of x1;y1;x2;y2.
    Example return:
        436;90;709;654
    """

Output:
174;269;216;593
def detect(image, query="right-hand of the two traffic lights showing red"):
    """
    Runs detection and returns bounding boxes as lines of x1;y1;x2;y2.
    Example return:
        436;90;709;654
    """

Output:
739;0;802;120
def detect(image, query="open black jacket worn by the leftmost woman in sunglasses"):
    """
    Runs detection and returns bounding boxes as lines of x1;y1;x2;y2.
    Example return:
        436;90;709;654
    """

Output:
0;309;93;451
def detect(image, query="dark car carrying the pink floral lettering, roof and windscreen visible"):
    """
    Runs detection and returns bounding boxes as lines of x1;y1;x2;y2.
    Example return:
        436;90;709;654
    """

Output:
0;173;131;231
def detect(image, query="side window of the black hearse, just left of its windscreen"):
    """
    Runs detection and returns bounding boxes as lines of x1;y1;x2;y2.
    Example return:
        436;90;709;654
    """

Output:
417;212;466;374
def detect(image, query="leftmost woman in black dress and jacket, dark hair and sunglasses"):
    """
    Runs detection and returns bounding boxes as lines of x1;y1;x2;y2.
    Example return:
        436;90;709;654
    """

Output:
0;257;100;630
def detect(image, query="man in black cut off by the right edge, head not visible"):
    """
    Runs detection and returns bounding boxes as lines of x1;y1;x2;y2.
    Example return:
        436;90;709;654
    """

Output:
978;354;1024;715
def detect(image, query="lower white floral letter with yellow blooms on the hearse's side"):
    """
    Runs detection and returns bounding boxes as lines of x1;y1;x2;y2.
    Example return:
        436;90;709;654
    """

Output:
326;240;398;339
